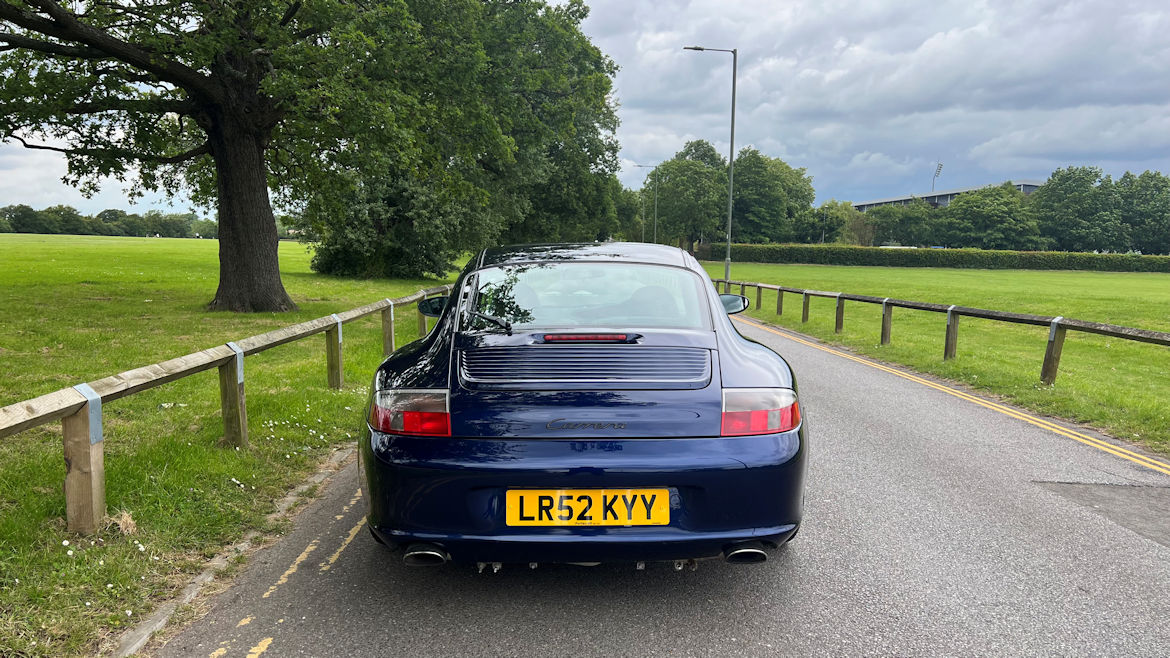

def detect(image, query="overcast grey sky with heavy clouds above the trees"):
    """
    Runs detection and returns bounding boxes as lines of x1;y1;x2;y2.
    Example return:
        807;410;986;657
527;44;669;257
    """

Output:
0;0;1170;213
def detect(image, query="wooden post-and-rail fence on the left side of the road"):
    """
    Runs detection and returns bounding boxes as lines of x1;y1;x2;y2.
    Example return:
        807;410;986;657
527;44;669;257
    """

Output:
0;286;450;534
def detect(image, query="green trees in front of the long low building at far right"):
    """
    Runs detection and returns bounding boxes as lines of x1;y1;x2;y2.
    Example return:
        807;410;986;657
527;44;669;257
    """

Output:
815;166;1170;254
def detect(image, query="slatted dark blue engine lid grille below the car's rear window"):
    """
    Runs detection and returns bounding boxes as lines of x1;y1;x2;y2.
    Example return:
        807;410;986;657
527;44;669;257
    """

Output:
459;345;711;390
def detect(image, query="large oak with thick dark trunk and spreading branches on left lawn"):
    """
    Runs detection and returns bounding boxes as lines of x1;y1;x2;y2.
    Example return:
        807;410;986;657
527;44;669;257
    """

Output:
0;0;430;311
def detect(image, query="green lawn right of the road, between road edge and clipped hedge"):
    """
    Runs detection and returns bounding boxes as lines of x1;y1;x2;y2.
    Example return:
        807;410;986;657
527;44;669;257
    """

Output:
706;262;1170;454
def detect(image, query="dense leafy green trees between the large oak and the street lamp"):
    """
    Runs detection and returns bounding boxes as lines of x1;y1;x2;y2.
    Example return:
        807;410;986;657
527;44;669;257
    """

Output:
297;0;621;275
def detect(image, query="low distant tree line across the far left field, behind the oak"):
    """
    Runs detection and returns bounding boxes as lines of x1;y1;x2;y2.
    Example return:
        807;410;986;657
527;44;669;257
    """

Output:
0;204;306;239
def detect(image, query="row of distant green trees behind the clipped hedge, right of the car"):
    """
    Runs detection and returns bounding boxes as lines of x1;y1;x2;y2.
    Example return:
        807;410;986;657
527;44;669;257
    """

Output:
641;161;1170;254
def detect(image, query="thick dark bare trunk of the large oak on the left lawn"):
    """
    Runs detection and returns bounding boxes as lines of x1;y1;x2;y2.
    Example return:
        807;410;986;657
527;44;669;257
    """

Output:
207;122;296;313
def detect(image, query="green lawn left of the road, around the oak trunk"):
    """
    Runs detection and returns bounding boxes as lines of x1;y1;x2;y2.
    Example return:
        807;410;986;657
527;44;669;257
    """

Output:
0;234;451;656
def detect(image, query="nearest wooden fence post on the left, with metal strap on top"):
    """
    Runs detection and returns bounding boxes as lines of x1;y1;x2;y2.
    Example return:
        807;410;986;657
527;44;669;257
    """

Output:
61;384;105;535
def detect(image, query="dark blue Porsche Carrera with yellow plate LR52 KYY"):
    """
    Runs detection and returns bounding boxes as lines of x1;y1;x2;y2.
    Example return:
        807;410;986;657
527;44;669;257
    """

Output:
359;242;807;569
